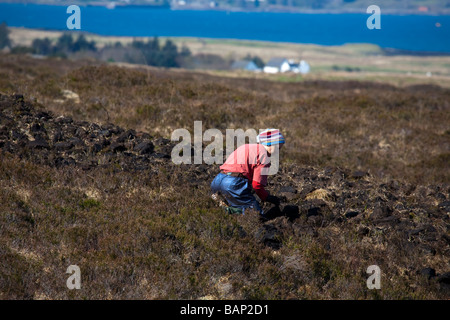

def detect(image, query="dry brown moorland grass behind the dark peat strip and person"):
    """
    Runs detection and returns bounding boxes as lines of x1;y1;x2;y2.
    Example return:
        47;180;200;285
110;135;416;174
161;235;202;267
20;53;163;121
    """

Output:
0;56;450;183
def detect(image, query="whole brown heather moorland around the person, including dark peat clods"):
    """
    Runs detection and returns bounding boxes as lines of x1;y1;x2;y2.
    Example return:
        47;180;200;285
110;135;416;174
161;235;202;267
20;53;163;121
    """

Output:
0;54;450;299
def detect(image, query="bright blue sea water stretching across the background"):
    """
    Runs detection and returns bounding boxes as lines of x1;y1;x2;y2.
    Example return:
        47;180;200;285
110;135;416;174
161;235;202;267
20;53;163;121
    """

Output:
0;3;450;53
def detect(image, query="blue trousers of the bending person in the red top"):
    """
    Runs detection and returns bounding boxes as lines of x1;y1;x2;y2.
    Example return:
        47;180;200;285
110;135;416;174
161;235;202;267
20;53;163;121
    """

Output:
211;173;263;214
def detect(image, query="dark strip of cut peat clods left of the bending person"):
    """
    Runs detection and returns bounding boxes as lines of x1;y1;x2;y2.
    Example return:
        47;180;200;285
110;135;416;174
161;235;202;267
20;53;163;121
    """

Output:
1;95;172;171
